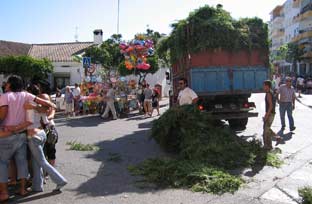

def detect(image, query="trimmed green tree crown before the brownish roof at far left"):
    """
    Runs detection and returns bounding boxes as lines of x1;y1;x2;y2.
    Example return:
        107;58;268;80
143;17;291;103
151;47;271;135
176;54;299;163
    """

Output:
0;56;53;82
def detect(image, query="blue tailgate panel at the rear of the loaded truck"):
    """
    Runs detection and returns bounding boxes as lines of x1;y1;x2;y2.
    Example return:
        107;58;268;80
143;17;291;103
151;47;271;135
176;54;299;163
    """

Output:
189;66;269;96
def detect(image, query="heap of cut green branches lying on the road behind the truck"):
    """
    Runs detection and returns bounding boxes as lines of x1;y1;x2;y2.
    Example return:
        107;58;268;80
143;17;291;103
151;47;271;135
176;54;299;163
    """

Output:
129;106;281;194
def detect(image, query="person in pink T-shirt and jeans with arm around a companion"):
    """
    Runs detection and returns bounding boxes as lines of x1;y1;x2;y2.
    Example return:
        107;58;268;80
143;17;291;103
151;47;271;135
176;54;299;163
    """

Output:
0;75;56;201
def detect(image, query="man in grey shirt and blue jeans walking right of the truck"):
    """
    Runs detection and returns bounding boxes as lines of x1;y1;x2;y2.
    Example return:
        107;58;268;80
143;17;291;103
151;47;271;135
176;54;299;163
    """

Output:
277;77;296;131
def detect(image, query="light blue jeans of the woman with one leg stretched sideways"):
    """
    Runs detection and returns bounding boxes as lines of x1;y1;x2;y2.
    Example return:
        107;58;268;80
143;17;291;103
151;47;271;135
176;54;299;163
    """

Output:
28;130;67;191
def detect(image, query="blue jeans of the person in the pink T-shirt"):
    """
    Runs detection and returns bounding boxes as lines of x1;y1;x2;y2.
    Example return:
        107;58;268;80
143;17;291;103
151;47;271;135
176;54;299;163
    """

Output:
0;133;28;183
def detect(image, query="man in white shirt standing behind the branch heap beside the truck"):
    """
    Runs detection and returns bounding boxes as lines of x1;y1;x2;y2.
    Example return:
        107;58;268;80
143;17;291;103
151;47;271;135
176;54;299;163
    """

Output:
178;78;198;106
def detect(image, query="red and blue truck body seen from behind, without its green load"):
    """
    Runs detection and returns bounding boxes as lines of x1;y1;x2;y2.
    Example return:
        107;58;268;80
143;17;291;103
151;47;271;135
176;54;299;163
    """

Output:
170;49;269;129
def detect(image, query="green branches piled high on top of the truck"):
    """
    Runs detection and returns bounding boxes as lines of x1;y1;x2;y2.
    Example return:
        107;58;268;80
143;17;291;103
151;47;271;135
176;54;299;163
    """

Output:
157;5;269;63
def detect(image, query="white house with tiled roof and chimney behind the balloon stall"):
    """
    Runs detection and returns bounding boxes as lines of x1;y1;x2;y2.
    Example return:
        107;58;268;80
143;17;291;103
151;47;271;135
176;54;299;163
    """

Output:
0;30;169;96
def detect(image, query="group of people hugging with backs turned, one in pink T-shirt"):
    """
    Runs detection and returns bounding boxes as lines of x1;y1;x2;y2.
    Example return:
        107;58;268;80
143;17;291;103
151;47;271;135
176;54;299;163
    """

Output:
0;75;67;201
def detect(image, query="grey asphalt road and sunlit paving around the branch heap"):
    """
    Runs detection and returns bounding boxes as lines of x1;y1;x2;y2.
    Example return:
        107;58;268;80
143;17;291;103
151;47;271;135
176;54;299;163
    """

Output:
7;94;312;204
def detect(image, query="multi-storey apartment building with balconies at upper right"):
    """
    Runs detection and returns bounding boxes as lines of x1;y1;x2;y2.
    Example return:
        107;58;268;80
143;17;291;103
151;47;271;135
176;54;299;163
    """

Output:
269;0;312;75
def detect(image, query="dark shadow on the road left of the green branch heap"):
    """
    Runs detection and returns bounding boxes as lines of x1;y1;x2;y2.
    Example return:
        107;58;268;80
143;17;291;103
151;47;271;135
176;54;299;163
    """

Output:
74;122;164;197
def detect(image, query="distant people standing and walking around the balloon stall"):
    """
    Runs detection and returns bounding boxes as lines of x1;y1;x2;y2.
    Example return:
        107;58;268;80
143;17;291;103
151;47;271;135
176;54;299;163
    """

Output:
61;81;161;120
